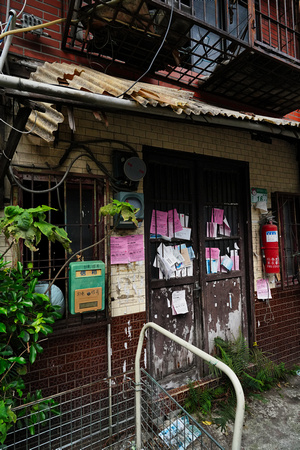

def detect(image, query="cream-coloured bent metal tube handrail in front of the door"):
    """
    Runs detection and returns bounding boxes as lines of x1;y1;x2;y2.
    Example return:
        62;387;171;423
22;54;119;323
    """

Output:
135;322;245;450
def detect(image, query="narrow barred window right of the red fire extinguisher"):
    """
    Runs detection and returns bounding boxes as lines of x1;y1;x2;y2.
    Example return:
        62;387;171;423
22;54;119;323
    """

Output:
273;192;300;288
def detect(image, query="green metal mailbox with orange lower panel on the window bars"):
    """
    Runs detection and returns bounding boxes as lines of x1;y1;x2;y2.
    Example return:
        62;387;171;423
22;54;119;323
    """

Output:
69;261;105;314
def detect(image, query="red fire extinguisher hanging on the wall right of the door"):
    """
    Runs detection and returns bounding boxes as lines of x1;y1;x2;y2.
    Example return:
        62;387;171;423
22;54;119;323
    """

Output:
261;222;280;273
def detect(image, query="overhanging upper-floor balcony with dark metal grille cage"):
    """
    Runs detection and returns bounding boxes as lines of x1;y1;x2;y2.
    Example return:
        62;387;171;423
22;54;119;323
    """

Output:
63;0;300;114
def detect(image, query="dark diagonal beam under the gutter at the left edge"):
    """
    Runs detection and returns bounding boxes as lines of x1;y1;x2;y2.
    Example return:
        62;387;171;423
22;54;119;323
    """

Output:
0;107;31;183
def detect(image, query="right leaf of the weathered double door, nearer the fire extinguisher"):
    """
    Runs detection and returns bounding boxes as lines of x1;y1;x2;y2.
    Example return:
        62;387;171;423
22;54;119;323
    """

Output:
198;159;252;353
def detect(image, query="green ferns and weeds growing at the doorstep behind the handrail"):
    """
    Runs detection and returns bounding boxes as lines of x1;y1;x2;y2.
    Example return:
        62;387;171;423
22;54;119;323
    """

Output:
185;333;297;431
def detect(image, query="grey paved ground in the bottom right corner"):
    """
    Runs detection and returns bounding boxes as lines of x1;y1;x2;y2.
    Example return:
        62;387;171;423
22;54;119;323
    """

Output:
200;375;300;450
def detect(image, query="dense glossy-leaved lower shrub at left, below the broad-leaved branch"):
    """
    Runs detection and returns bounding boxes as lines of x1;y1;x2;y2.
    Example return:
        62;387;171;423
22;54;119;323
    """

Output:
0;258;61;443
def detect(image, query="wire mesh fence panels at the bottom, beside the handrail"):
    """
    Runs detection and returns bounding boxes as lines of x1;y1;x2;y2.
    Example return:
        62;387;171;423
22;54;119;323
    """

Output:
4;370;222;450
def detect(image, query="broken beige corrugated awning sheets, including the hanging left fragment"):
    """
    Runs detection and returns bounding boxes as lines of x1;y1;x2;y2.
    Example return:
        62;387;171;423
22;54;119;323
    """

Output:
26;62;300;141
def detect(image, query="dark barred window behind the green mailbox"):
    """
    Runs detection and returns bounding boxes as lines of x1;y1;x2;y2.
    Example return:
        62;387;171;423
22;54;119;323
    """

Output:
18;172;106;327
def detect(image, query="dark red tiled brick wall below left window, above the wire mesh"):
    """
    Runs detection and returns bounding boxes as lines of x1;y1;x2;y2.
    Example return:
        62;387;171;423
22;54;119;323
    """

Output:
25;312;146;396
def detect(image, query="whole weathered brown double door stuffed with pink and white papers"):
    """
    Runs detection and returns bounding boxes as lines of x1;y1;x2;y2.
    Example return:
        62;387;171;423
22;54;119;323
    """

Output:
144;148;250;388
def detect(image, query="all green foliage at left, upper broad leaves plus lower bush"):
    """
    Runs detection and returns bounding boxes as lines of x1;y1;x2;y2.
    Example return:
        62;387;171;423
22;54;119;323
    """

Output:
0;206;70;444
